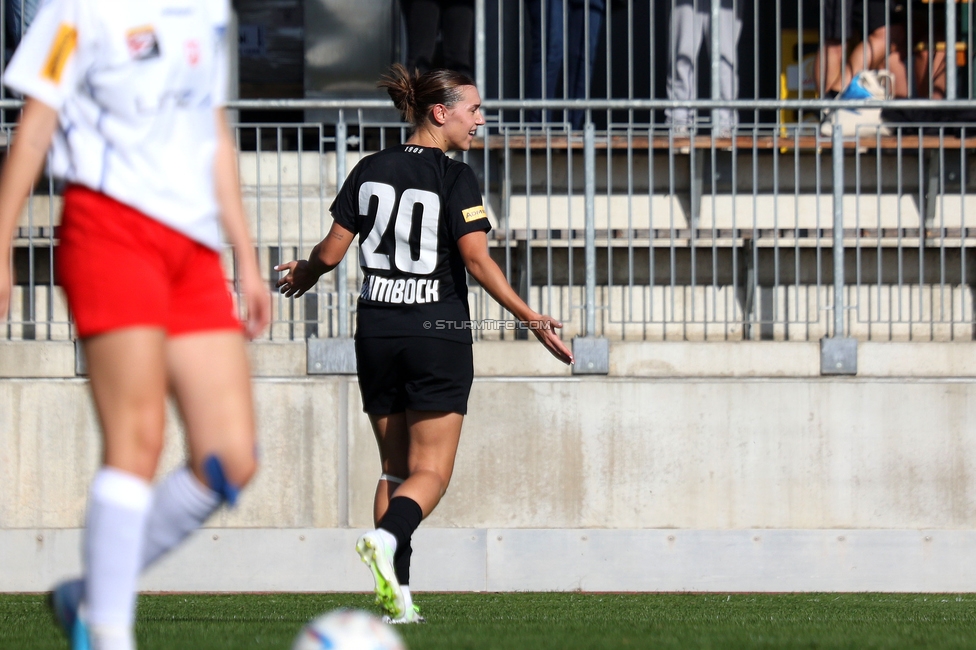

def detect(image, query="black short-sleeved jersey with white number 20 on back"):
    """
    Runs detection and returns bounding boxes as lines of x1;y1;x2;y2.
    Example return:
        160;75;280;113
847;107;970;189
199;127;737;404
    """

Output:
331;145;491;343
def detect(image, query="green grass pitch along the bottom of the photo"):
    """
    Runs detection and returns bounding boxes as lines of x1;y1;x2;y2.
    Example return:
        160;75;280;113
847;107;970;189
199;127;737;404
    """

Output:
0;593;976;650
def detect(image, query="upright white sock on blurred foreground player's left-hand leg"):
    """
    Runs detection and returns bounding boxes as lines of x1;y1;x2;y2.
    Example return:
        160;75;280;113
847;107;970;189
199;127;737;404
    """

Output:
84;467;152;632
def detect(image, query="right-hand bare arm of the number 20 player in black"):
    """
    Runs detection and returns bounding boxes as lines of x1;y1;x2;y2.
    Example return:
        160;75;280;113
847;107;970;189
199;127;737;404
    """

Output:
458;231;574;363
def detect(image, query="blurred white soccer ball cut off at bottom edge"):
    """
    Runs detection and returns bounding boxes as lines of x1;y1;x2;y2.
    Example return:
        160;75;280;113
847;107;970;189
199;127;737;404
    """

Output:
291;609;407;650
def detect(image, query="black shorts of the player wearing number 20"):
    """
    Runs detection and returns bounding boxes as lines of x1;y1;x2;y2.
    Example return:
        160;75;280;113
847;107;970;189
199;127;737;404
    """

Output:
356;336;474;415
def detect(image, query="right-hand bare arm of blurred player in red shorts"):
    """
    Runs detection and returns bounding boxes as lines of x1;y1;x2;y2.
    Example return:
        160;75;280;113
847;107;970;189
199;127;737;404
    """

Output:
214;109;271;339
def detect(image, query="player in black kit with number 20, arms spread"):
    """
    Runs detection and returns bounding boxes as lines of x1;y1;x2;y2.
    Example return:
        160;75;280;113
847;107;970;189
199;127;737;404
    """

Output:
275;65;573;623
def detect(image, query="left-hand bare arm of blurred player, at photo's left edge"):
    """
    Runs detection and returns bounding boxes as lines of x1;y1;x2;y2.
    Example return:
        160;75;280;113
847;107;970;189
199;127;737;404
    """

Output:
0;98;58;319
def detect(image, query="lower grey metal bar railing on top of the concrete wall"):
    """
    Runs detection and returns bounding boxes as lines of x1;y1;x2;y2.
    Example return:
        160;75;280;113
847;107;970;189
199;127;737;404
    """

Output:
0;100;976;340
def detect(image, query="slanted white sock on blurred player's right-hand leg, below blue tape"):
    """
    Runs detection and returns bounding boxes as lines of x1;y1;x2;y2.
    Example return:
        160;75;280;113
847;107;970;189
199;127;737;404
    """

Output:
142;466;221;569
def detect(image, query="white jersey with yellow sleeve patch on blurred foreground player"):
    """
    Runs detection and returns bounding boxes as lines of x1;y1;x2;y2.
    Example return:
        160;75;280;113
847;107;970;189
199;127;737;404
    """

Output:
4;0;230;249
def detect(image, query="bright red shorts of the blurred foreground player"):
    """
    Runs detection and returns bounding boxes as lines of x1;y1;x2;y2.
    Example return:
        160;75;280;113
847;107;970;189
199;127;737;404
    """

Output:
56;185;241;338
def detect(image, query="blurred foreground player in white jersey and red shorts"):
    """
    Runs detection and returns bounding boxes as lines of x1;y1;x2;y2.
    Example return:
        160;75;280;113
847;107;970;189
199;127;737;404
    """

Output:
0;0;271;650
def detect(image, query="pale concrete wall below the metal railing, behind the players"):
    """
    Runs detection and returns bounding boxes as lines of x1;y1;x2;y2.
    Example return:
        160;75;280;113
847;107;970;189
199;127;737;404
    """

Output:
0;342;976;591
